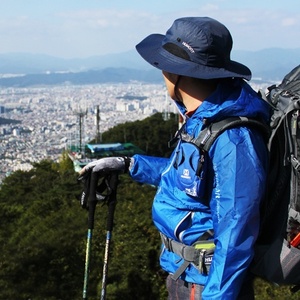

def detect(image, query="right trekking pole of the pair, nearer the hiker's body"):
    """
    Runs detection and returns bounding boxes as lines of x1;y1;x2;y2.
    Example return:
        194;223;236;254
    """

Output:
100;173;118;300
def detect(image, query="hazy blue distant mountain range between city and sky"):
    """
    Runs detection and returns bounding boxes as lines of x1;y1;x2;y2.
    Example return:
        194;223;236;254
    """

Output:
0;48;300;87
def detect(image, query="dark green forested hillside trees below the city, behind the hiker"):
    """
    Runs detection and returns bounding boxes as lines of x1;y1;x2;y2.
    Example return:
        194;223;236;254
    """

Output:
0;115;299;300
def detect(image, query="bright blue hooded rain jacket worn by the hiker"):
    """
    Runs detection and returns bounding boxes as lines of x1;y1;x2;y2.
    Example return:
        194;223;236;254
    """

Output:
130;79;269;300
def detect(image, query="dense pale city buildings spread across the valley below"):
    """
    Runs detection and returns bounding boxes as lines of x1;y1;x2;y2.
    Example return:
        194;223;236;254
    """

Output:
0;82;264;184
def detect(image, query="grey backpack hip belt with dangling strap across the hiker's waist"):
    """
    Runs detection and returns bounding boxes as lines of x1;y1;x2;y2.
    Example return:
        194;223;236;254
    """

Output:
160;229;214;280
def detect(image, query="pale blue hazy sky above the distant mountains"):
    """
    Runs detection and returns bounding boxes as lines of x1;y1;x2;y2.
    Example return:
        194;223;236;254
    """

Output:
0;0;300;59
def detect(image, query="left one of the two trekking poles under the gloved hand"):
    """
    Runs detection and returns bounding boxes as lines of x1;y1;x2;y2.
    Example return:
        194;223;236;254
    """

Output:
82;173;98;300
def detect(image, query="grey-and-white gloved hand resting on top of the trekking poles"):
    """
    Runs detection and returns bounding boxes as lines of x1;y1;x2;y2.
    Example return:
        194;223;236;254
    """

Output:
79;156;131;177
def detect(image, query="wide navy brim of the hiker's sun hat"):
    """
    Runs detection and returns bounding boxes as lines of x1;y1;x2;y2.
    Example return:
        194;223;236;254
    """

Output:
136;34;251;80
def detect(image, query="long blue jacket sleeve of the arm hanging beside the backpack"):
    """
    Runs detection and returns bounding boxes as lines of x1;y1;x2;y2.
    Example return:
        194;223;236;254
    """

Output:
202;128;267;300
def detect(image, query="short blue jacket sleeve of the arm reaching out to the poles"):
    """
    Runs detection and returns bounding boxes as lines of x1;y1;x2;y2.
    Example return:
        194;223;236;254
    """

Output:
130;154;169;186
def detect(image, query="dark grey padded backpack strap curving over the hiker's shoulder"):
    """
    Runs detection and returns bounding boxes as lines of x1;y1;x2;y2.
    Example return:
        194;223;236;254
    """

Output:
191;117;270;151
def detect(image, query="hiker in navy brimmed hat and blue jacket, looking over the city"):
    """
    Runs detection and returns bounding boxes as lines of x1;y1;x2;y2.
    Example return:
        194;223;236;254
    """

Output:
81;17;269;300
